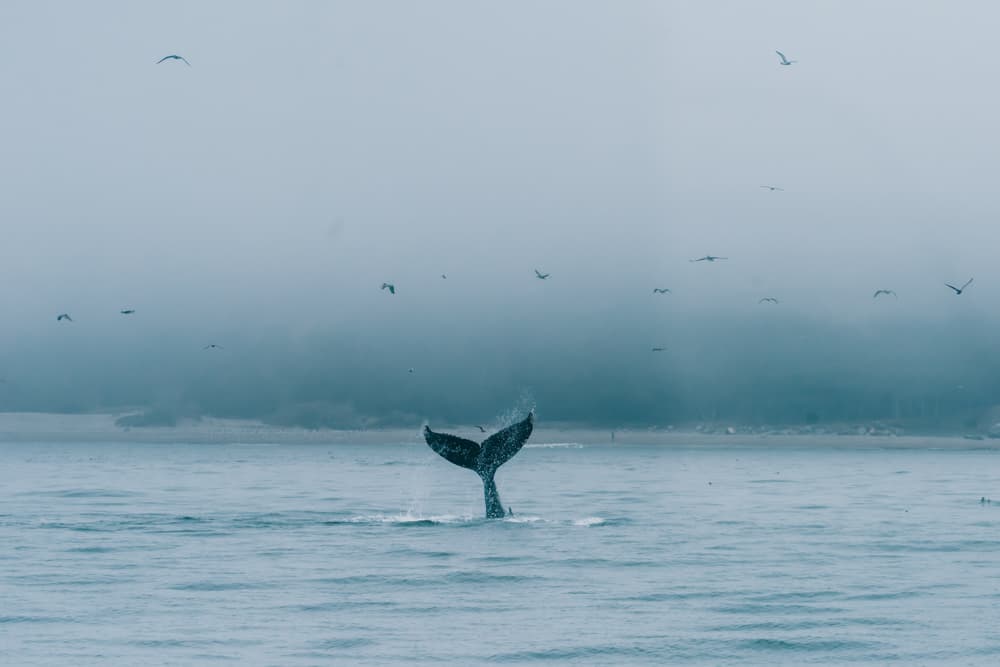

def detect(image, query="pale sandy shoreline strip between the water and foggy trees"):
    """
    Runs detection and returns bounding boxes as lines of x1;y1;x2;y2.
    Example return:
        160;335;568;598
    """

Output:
0;412;1000;450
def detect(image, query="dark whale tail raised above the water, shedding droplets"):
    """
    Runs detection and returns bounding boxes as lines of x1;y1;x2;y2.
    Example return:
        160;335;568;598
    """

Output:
424;413;534;519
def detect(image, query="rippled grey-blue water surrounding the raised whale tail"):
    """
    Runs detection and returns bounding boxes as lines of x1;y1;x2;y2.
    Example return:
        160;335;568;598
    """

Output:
0;443;1000;665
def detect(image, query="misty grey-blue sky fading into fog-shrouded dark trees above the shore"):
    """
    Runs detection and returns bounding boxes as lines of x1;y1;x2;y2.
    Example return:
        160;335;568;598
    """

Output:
0;0;1000;422
